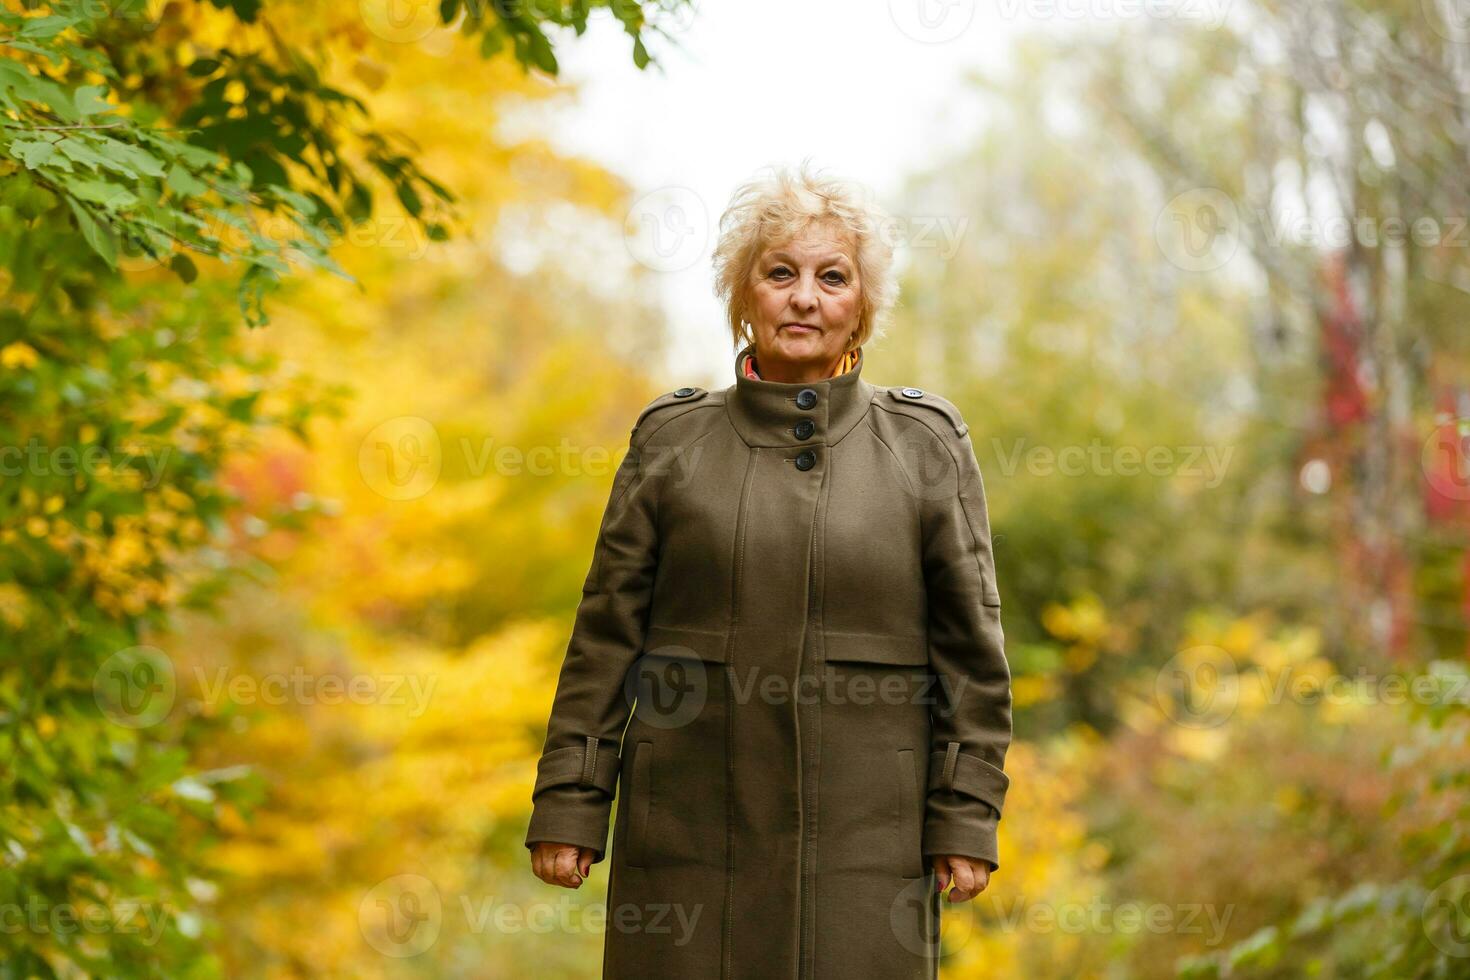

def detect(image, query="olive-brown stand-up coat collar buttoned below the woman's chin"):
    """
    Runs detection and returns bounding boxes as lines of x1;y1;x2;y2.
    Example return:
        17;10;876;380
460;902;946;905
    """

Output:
725;345;875;448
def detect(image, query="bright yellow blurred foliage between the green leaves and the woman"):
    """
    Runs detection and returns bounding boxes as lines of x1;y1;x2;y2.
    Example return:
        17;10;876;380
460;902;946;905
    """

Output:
123;11;679;977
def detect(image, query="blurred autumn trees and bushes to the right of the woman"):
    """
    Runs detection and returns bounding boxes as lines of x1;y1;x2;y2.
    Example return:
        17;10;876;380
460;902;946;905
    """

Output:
883;11;1470;977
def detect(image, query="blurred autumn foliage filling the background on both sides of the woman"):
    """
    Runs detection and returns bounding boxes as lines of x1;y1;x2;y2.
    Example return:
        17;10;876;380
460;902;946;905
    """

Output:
0;0;1470;979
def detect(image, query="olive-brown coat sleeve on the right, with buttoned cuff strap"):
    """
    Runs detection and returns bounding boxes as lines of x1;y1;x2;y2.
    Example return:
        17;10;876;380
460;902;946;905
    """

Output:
920;432;1011;868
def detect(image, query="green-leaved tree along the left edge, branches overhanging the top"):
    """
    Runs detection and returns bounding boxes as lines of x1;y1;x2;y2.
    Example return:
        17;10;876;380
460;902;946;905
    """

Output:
0;0;679;977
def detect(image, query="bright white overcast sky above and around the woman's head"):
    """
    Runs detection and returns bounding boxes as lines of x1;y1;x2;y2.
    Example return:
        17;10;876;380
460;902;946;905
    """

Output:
537;0;1230;388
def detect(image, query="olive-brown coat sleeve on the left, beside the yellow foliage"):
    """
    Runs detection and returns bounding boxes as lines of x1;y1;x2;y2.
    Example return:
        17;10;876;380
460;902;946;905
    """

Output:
526;428;662;862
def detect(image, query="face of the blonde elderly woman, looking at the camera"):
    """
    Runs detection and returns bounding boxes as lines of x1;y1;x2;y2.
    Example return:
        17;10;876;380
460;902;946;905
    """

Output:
747;225;863;382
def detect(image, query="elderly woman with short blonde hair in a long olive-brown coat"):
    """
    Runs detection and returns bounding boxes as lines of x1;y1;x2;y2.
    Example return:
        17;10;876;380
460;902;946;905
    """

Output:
526;167;1011;980
